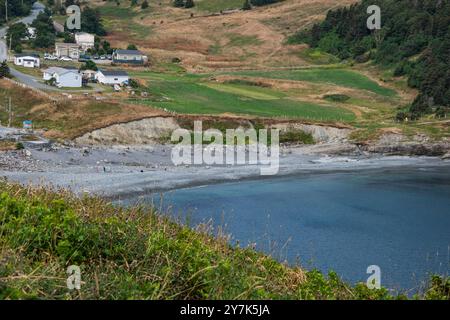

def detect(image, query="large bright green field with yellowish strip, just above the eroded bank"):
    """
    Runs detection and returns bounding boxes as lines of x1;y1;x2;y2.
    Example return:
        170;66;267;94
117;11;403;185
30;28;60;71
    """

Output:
129;73;355;122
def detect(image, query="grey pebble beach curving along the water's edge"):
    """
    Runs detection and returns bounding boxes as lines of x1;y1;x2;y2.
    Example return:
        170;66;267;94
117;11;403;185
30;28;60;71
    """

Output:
0;144;450;199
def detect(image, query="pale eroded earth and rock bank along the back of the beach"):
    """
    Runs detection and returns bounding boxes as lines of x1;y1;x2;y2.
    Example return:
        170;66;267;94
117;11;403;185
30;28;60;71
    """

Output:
75;117;450;157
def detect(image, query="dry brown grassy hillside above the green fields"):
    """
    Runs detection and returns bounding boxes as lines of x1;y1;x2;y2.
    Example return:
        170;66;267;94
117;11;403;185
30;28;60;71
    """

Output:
96;0;355;71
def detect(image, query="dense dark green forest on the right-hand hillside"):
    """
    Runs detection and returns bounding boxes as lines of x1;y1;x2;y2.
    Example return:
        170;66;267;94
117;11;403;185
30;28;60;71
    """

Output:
290;0;450;120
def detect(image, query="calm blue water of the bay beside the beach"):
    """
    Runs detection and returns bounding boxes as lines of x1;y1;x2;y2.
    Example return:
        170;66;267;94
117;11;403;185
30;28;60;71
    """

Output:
147;168;450;290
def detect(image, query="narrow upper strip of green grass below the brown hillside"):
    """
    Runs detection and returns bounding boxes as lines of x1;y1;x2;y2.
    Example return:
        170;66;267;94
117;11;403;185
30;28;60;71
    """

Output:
227;68;396;97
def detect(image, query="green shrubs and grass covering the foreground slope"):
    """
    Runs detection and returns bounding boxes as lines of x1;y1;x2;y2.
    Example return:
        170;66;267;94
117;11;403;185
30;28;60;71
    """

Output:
0;181;449;299
